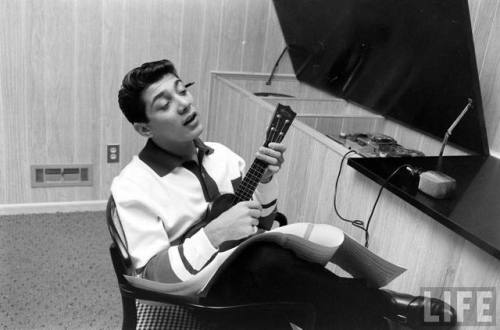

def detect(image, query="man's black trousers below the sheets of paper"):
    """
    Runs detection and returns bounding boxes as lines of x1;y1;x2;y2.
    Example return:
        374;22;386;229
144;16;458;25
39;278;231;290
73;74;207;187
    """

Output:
206;242;389;330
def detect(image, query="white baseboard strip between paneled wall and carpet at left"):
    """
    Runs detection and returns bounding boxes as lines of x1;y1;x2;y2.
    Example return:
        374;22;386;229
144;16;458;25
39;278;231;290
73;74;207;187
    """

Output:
0;200;107;215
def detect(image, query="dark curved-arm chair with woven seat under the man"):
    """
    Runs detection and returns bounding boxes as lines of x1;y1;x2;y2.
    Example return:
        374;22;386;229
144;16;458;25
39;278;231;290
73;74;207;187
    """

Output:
106;196;315;330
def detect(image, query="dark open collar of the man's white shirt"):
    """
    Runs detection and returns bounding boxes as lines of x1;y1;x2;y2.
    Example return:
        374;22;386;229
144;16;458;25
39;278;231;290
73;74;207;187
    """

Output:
139;138;214;176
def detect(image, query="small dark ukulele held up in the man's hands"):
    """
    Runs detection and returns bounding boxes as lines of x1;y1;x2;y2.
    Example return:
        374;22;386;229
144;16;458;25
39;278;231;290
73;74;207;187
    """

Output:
184;104;296;252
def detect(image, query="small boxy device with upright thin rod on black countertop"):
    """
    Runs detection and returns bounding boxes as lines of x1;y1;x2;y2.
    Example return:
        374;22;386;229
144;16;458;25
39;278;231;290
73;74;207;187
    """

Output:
418;99;472;199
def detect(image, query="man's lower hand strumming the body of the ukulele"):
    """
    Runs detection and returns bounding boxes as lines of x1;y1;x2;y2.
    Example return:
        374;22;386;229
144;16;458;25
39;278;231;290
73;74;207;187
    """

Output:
205;201;262;248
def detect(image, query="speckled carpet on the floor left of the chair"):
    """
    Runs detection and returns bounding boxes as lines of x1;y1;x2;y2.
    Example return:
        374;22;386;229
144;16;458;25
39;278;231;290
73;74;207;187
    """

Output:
0;212;122;330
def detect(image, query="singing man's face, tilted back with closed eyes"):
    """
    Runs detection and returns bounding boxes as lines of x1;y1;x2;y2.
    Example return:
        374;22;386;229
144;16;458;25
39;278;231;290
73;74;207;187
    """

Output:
142;74;203;145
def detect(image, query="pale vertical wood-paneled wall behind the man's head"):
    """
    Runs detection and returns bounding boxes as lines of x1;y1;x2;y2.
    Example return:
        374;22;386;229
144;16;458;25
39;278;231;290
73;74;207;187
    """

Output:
0;0;287;203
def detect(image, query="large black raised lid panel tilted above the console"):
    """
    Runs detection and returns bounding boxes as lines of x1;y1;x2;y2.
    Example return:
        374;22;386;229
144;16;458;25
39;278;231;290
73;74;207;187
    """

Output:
274;0;488;154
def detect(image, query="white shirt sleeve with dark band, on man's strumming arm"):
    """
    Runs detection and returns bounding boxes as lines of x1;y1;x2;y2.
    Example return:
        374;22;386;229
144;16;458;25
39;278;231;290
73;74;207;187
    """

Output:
111;180;218;283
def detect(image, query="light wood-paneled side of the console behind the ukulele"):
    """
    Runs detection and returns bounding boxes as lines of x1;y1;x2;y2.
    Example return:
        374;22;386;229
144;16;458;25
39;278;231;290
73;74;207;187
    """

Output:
208;74;500;330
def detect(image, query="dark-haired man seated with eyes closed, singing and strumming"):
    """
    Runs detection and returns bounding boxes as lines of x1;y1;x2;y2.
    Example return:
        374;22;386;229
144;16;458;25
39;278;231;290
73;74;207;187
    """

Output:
111;60;453;329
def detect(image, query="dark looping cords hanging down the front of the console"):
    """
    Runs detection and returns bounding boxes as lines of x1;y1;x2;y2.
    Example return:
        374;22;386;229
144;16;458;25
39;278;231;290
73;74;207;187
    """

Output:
333;150;416;248
